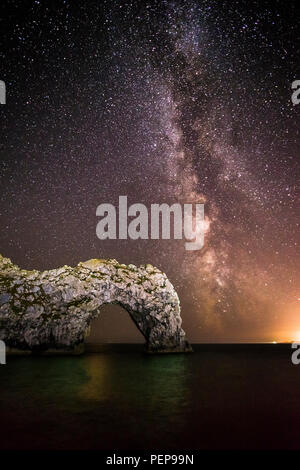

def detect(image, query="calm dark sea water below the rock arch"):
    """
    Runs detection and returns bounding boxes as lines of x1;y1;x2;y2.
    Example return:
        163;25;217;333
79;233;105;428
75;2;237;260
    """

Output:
0;346;300;450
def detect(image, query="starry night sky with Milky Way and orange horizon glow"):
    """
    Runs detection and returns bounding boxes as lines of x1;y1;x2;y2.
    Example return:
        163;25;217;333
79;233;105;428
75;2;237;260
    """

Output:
0;0;300;342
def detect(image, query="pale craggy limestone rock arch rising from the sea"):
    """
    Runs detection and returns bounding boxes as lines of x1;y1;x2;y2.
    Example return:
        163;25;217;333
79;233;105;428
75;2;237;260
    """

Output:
0;255;191;353
